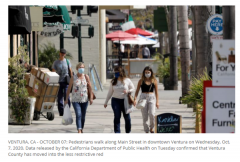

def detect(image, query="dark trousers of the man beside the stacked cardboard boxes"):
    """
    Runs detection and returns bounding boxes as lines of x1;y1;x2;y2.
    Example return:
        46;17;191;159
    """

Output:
58;82;71;116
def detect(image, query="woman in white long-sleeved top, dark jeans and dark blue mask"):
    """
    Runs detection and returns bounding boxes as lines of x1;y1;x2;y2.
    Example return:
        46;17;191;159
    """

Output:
104;67;134;133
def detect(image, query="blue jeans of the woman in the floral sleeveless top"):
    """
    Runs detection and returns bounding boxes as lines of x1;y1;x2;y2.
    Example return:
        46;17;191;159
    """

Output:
72;101;88;129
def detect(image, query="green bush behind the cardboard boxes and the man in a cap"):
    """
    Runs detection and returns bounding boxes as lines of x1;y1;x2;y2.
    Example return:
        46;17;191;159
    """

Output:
38;42;72;70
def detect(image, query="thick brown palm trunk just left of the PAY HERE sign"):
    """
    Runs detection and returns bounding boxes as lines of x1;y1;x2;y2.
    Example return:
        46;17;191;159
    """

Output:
194;6;209;75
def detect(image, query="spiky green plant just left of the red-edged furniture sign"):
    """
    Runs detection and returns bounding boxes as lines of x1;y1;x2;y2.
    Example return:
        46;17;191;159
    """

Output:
182;68;212;133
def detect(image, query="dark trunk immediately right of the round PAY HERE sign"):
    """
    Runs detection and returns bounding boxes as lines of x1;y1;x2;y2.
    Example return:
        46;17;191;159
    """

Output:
222;6;235;39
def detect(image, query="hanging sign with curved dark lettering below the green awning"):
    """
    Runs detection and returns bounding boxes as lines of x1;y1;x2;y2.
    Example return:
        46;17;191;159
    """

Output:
38;23;63;37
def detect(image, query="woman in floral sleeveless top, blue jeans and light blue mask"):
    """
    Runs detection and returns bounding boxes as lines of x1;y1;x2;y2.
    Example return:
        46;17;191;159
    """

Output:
65;62;93;133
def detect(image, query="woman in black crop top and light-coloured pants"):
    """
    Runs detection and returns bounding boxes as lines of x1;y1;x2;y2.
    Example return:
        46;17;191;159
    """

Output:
134;66;159;133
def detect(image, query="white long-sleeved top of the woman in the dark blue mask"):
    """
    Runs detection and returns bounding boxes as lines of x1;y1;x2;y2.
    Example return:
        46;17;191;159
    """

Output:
105;78;134;105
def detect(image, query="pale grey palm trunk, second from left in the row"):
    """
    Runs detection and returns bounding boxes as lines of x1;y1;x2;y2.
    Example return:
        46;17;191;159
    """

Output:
178;6;190;96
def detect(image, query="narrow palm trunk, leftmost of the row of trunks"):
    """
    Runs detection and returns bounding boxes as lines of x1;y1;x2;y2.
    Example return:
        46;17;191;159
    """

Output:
170;6;178;90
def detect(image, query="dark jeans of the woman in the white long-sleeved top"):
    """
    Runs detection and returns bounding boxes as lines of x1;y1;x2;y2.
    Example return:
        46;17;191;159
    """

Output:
112;98;131;133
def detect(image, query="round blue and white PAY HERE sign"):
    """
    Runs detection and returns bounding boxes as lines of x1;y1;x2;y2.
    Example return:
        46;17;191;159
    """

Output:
206;14;223;35
